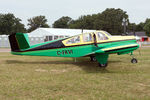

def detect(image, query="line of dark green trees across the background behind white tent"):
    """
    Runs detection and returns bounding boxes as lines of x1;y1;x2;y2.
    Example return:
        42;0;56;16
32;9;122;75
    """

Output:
0;8;150;36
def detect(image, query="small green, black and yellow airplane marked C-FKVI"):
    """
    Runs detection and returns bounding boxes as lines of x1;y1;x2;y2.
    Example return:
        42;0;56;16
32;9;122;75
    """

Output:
9;31;139;67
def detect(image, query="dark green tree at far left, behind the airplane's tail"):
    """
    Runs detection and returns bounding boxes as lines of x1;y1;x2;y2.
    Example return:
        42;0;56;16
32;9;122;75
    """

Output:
0;13;26;35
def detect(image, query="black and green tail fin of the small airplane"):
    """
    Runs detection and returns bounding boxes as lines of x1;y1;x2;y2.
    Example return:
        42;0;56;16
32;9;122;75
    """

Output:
9;33;30;52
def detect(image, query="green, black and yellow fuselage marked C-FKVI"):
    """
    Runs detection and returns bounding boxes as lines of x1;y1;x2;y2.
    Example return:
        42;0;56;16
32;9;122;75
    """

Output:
12;31;139;57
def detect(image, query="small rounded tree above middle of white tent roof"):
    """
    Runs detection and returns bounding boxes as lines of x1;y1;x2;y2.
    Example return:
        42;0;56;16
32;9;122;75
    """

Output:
53;16;72;28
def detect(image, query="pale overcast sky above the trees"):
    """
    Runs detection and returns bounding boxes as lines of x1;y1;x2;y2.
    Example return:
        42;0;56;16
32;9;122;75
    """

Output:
0;0;150;25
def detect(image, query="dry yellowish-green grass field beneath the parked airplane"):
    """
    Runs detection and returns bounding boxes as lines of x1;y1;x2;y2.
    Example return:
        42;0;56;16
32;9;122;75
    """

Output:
0;48;150;100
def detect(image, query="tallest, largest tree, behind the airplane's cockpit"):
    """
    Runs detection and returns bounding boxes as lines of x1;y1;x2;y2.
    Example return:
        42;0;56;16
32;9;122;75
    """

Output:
94;8;129;34
